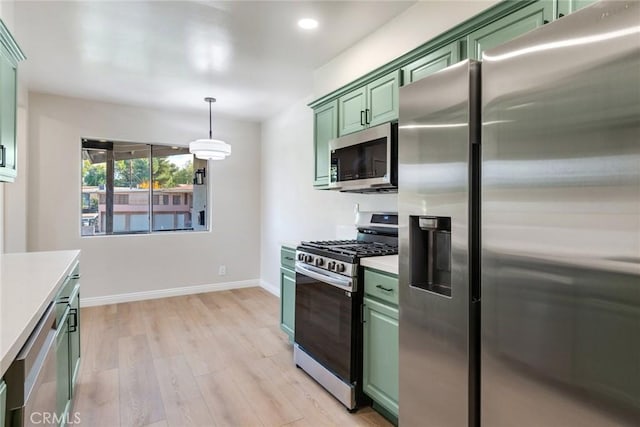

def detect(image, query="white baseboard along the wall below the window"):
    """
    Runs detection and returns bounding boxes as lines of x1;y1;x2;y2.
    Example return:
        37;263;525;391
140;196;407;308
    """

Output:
81;279;262;307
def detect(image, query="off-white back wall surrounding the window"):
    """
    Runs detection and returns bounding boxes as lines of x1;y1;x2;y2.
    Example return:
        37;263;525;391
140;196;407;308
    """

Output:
28;93;260;298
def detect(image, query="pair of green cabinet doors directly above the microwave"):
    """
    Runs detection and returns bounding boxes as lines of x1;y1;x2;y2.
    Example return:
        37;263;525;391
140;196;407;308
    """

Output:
338;70;400;136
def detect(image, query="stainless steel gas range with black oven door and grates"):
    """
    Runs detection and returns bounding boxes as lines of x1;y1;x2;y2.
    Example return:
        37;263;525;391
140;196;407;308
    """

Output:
294;212;398;410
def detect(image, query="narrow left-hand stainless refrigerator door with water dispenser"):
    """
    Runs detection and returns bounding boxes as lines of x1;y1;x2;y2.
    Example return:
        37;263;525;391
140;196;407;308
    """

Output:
398;61;478;427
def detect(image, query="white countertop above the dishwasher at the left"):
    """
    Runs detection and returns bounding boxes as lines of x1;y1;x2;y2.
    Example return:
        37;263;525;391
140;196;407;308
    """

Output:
0;250;80;377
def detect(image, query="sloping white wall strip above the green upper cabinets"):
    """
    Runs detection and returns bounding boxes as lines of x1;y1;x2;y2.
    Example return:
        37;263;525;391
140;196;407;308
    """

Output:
313;0;501;98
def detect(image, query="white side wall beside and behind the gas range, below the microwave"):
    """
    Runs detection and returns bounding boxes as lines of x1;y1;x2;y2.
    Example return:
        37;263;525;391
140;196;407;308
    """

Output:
260;98;397;290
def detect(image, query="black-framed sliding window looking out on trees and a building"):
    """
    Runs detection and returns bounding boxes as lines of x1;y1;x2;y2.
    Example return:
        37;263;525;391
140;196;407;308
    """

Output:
81;139;208;236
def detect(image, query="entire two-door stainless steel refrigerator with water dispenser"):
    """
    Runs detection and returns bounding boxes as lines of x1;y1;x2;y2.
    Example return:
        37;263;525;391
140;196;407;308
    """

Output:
398;1;640;427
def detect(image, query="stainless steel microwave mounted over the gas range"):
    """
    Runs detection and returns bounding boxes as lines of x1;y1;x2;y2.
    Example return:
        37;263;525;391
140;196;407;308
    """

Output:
329;123;398;193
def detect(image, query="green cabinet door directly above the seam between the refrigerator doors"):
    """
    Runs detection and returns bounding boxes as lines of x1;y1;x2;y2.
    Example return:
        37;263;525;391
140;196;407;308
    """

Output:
467;0;554;60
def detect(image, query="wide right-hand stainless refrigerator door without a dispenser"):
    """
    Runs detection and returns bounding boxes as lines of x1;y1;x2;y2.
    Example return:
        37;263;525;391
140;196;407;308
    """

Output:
481;1;640;427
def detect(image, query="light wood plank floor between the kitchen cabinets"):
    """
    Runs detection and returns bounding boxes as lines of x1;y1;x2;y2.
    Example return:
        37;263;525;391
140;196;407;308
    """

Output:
71;288;390;427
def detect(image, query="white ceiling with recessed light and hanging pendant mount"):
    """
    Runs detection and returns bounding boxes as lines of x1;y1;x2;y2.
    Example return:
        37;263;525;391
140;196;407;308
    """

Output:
15;1;415;120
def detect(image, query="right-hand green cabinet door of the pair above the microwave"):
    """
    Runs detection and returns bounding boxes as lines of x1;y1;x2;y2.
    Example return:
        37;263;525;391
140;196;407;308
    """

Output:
365;70;401;126
